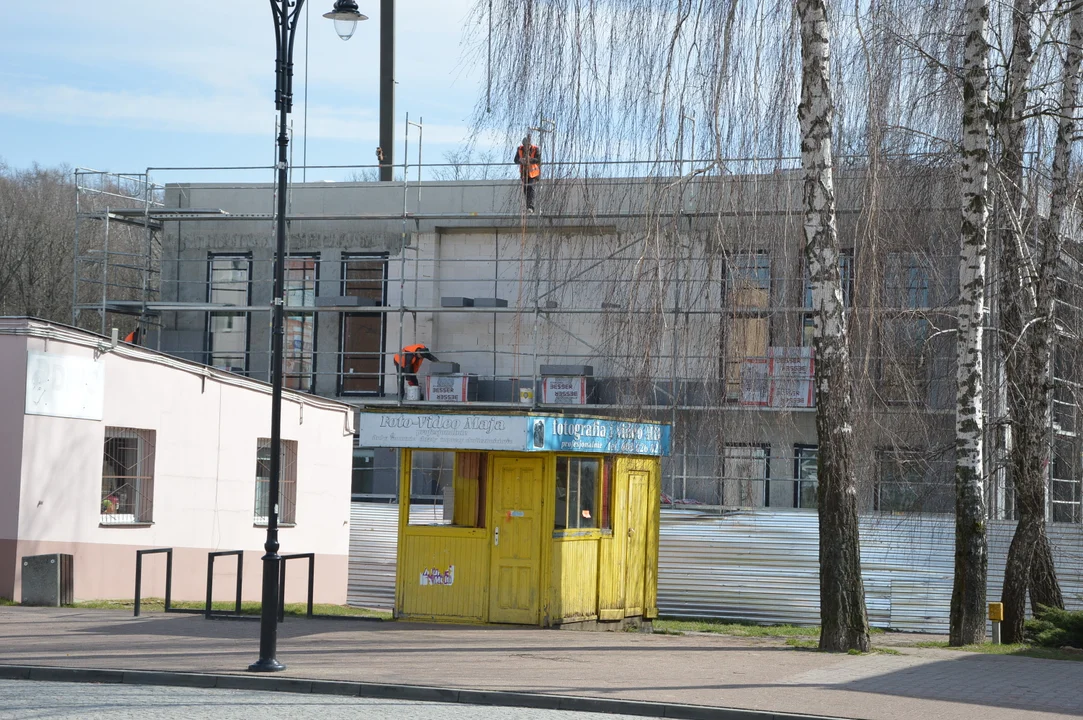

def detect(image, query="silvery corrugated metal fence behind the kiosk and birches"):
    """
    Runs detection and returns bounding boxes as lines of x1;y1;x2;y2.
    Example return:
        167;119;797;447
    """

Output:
349;502;1083;632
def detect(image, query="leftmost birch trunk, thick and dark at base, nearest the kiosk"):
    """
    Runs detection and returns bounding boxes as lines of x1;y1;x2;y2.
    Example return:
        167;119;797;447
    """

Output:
796;0;869;652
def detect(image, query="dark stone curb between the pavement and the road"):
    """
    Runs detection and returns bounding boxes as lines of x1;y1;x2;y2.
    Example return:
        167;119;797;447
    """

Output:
0;665;837;720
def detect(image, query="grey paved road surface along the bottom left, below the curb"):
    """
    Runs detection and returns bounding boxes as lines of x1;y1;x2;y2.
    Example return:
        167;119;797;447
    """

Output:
0;680;658;720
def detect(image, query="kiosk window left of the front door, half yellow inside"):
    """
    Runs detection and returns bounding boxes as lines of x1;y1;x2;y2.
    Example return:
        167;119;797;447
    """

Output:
409;450;487;527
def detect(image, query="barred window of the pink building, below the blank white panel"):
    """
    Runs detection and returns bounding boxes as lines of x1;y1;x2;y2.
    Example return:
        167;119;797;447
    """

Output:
101;428;155;525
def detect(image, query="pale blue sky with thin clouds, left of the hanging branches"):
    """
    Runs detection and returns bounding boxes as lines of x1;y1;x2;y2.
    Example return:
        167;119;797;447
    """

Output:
0;0;485;182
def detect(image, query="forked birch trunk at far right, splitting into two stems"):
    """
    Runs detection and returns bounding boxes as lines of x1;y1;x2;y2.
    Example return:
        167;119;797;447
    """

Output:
1000;0;1079;642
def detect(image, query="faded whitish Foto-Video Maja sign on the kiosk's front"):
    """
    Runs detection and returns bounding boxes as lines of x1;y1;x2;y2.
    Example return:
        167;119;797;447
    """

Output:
357;413;526;450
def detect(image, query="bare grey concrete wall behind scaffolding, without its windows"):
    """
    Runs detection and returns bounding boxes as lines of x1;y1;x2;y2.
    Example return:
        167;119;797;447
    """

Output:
162;172;956;509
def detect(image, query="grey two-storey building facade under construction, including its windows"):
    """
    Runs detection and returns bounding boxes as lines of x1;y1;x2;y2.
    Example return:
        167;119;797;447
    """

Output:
137;169;1080;522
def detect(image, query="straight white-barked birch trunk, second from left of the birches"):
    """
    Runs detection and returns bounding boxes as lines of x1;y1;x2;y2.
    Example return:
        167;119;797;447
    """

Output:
949;0;989;645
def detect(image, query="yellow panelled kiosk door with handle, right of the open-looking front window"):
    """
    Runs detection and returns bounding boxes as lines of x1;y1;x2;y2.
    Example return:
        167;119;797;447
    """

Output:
488;458;544;625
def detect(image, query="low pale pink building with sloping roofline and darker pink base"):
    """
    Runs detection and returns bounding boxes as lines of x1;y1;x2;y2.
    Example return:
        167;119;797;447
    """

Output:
0;317;353;604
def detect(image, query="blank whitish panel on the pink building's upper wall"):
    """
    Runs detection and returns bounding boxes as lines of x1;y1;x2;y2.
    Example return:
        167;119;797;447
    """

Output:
25;350;105;420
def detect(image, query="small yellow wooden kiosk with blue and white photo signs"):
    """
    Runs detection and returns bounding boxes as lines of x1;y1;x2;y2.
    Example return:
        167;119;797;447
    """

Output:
360;408;669;627
